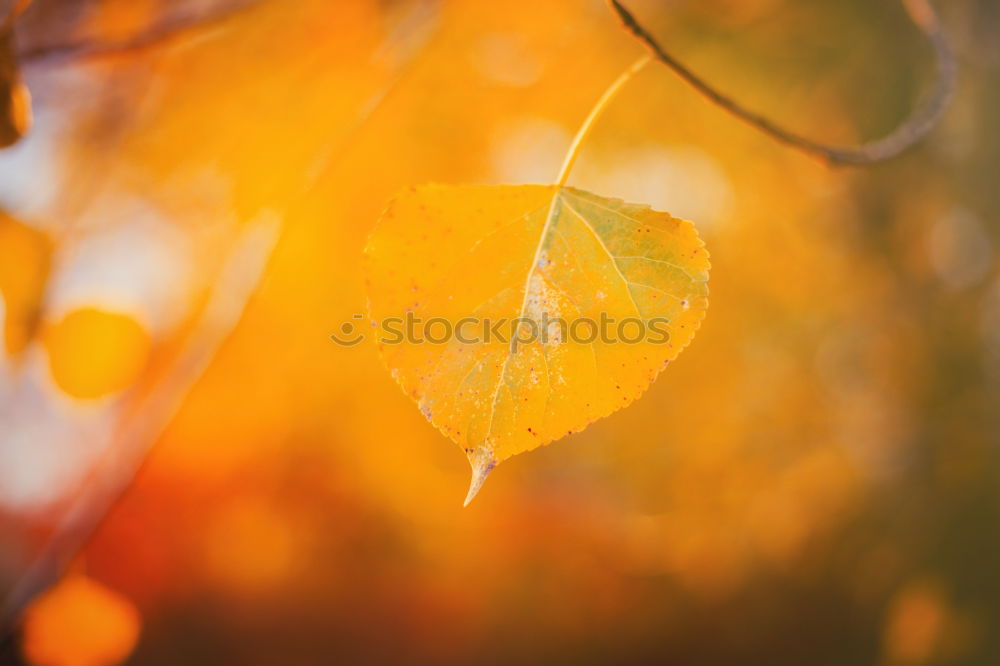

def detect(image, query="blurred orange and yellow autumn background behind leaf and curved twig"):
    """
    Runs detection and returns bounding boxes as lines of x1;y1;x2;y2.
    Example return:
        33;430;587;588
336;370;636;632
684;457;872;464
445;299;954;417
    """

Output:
0;0;1000;666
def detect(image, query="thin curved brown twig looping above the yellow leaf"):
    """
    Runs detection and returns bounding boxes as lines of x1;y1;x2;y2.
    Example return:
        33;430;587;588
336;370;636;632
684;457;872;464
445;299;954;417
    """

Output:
608;0;957;165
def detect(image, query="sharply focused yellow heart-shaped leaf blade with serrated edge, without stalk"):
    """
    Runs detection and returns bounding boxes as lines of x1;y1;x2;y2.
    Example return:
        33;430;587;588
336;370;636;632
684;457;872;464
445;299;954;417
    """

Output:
366;180;709;502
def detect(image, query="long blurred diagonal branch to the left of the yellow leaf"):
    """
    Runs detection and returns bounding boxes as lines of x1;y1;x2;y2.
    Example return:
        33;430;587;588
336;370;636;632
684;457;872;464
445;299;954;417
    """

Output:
0;0;437;628
